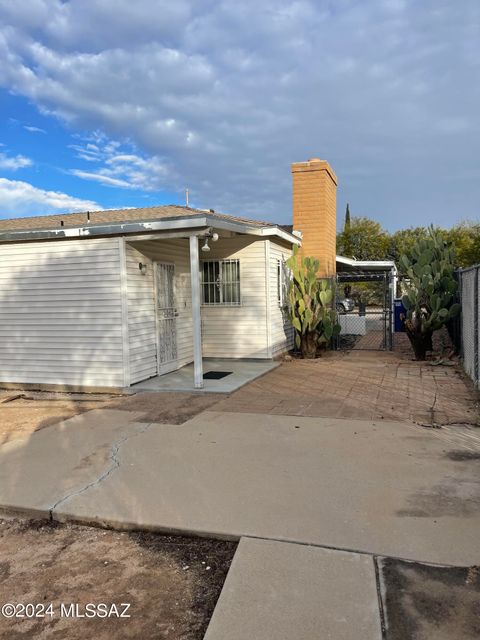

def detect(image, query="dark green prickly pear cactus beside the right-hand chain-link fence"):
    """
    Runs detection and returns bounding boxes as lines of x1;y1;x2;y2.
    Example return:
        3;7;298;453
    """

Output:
400;226;460;360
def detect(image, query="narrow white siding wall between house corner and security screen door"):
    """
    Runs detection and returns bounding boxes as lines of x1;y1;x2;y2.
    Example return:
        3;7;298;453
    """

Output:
125;243;157;384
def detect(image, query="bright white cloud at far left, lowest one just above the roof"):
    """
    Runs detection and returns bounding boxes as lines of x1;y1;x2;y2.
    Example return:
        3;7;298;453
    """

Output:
0;178;102;218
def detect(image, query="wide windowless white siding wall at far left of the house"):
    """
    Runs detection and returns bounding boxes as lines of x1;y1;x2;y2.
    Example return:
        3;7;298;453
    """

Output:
0;239;124;387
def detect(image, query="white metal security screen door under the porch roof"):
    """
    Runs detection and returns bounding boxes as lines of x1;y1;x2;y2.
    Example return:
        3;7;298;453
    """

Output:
155;262;177;375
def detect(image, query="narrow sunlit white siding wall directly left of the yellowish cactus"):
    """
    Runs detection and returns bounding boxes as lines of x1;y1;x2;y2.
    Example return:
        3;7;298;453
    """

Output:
269;241;294;357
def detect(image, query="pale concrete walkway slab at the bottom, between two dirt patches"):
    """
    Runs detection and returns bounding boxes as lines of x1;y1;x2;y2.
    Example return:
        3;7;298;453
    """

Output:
205;538;382;640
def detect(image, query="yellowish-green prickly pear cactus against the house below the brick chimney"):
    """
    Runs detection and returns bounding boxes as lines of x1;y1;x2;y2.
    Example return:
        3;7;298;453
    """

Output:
286;247;340;358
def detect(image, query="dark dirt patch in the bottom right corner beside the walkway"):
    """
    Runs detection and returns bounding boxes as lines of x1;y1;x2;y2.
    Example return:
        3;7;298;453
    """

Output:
377;558;480;640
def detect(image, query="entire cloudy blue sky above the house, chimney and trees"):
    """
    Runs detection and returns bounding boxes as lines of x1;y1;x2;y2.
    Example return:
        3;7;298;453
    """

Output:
0;0;480;230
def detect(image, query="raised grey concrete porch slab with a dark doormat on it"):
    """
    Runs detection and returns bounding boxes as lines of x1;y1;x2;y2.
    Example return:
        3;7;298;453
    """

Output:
130;358;279;393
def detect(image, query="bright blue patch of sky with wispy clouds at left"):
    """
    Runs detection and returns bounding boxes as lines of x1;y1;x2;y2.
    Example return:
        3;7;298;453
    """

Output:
0;90;180;217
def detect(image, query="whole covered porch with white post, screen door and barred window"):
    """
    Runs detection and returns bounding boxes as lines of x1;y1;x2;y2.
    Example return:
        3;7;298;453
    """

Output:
122;216;296;393
